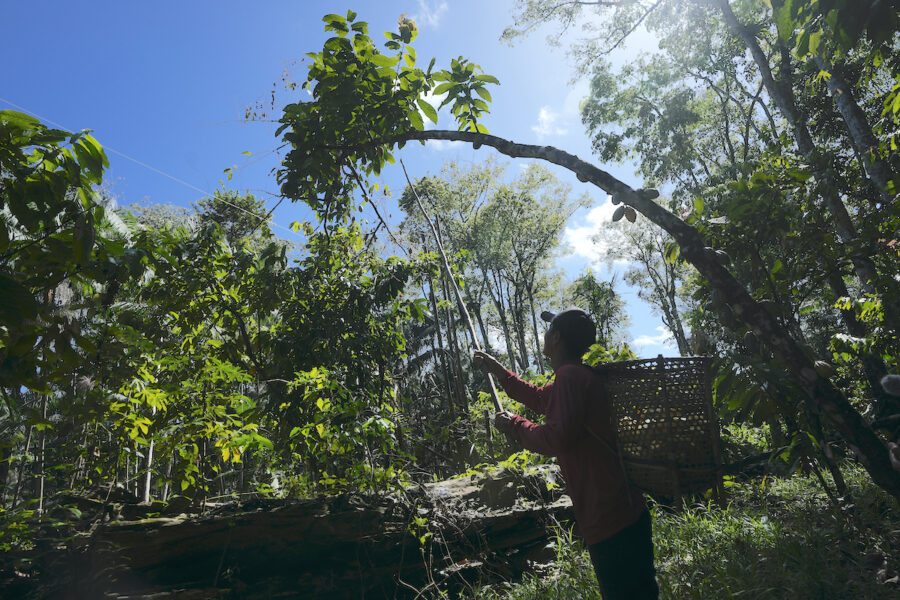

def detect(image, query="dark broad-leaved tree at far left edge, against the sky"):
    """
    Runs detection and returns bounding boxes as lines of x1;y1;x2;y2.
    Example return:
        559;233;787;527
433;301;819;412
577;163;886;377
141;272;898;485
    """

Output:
0;110;127;390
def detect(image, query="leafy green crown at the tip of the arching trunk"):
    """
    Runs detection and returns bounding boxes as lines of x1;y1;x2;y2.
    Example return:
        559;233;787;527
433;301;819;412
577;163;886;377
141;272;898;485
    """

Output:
278;11;499;222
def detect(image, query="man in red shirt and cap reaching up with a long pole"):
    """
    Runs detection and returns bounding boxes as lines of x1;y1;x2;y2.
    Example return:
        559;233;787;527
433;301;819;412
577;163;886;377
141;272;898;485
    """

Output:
474;307;659;600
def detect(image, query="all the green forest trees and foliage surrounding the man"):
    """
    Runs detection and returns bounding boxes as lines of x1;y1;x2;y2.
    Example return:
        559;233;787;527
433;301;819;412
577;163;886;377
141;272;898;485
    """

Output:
0;0;900;592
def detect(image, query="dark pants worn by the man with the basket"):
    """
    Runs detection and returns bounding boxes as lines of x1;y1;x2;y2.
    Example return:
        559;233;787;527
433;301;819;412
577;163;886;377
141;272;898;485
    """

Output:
588;512;659;600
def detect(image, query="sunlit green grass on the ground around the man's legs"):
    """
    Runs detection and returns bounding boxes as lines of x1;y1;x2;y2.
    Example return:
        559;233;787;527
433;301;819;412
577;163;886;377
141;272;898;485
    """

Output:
471;464;900;600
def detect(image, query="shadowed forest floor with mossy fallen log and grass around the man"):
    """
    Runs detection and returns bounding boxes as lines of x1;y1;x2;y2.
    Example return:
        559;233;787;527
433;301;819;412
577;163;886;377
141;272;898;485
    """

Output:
0;463;900;600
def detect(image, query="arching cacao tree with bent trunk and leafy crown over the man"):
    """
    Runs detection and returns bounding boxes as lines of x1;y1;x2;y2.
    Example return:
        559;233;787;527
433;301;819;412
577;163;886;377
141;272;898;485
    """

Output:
279;12;900;497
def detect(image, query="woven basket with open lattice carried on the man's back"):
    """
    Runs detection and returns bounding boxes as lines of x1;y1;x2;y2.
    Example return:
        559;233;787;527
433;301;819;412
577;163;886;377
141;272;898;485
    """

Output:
594;355;722;499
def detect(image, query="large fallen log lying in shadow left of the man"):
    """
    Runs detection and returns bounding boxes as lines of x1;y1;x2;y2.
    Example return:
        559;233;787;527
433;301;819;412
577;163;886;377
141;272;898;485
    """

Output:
31;466;573;600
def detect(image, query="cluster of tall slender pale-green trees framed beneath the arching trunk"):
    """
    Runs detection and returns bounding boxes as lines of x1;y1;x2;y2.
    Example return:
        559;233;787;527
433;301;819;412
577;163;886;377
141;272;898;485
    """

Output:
400;161;588;371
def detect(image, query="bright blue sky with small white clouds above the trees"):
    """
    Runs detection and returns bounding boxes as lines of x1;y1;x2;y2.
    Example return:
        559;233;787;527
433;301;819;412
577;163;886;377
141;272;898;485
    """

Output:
0;0;675;356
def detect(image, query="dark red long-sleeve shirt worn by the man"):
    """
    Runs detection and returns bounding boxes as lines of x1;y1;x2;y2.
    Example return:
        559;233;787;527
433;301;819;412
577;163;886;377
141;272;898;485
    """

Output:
500;364;647;545
